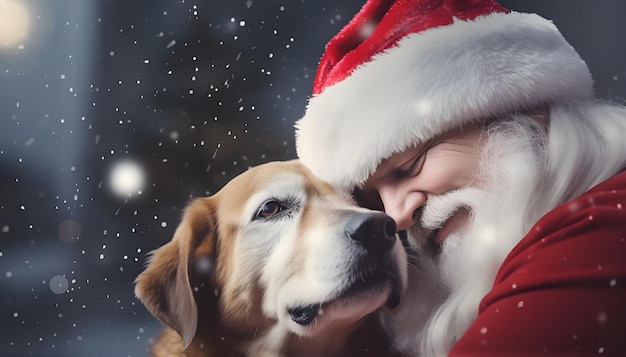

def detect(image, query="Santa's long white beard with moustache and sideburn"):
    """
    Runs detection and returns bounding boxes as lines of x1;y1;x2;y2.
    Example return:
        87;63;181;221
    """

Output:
382;117;545;357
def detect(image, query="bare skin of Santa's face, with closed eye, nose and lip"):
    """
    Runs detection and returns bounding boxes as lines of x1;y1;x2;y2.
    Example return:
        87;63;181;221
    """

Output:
357;125;482;244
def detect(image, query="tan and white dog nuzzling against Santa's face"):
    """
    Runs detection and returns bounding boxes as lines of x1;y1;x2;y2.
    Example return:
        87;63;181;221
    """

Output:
135;160;407;357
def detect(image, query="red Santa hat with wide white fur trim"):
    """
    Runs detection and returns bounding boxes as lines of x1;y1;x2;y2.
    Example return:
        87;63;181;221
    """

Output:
296;0;593;191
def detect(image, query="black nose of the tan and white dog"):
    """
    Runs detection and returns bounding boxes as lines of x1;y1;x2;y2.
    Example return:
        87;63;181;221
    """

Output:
345;212;398;252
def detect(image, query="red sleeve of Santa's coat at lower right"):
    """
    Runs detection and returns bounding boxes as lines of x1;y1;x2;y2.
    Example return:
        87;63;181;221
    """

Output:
449;173;626;357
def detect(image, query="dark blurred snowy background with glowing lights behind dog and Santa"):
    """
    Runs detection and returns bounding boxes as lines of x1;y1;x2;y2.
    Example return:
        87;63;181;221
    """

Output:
0;0;626;357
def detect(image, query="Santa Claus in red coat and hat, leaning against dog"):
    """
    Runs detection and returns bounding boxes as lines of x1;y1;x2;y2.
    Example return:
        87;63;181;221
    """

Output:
296;0;626;356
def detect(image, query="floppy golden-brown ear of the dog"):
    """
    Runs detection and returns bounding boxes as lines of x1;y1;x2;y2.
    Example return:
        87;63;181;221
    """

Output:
135;198;217;347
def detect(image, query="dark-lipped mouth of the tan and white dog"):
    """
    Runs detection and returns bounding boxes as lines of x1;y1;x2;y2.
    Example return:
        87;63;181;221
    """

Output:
287;262;403;326
